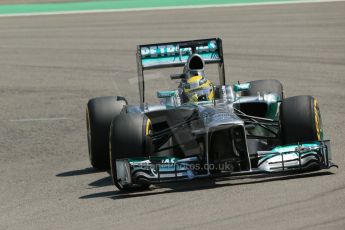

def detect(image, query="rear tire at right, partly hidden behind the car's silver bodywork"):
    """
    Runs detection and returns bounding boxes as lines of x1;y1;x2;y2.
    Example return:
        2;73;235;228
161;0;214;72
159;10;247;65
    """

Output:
242;80;284;100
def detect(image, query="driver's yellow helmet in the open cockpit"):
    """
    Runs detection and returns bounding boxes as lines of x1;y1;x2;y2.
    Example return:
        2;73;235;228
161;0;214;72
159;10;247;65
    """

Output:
182;74;214;103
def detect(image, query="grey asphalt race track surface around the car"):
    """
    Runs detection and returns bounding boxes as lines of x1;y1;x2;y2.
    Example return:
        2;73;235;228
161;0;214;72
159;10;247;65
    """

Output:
0;2;345;230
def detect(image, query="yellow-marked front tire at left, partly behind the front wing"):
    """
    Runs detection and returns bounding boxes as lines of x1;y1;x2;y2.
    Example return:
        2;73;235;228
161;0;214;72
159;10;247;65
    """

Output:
109;113;152;191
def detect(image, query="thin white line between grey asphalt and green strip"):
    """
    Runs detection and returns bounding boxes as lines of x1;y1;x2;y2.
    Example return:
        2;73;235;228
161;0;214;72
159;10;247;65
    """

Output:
0;0;345;17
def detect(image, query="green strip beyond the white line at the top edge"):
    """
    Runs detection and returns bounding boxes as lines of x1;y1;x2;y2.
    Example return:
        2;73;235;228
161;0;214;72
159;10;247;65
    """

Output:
0;0;296;14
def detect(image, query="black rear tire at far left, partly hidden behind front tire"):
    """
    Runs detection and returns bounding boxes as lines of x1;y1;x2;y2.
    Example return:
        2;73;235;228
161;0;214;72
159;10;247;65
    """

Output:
86;96;127;170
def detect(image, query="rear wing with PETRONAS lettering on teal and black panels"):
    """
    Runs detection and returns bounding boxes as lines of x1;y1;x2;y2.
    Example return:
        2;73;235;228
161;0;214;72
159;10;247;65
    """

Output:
137;38;225;104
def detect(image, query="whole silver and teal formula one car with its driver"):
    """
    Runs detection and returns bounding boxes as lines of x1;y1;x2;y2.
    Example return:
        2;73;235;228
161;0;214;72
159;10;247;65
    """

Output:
86;38;335;190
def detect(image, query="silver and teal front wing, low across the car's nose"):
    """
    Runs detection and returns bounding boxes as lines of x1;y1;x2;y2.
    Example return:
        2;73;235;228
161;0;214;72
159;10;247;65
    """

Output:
116;141;337;186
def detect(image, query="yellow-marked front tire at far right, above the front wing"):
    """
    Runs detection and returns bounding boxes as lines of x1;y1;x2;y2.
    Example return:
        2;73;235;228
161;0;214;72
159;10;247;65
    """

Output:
280;96;323;144
